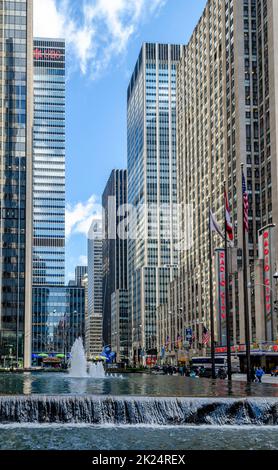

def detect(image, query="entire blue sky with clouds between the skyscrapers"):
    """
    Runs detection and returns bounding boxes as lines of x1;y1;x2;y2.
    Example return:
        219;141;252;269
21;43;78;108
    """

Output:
34;0;206;280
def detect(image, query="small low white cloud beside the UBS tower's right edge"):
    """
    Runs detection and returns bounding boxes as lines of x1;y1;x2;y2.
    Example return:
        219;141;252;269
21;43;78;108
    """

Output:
66;195;102;239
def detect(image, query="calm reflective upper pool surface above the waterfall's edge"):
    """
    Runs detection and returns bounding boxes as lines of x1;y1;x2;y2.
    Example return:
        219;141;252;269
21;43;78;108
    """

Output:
0;372;278;397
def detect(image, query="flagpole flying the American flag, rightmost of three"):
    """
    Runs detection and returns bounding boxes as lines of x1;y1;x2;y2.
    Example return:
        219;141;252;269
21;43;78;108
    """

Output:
241;163;251;383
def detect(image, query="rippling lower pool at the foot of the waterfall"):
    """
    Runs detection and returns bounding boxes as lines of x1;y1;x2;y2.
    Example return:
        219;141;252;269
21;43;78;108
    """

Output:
0;425;278;450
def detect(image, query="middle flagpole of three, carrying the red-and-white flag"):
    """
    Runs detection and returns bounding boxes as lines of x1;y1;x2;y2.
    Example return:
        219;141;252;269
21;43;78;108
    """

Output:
224;181;232;380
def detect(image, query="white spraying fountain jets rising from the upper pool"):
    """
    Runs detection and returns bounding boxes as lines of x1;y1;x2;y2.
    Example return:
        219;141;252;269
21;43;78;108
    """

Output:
69;338;106;379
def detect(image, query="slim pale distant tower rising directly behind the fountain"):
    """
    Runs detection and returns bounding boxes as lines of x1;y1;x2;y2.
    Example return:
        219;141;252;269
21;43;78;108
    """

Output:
85;220;103;358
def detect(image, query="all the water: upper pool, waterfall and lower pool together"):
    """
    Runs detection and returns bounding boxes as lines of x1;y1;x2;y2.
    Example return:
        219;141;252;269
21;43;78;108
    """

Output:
0;369;278;450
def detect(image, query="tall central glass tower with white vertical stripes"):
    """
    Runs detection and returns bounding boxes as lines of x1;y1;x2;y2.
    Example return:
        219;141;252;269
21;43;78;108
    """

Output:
127;43;181;362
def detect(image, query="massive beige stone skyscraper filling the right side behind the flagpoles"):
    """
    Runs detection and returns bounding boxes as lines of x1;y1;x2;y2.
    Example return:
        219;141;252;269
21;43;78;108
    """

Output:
160;0;278;362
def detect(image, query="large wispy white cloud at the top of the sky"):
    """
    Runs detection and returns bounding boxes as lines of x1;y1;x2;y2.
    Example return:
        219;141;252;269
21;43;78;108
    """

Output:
34;0;167;78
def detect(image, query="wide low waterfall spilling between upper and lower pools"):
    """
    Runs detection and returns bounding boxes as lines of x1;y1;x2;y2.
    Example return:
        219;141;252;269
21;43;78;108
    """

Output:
0;395;278;426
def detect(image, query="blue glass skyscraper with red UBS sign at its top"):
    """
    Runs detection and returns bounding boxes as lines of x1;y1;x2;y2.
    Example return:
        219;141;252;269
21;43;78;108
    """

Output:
33;39;65;286
